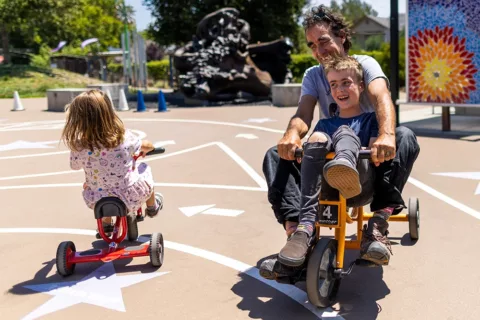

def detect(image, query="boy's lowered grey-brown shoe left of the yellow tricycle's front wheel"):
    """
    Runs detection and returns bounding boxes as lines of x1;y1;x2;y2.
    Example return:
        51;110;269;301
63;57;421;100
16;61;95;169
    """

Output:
278;231;310;267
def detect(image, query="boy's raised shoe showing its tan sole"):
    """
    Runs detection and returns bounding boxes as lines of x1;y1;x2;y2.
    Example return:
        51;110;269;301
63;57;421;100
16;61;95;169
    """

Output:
323;159;362;199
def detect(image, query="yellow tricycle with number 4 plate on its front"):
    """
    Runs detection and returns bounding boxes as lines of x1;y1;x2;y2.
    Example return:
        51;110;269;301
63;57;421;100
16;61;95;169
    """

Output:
295;149;420;308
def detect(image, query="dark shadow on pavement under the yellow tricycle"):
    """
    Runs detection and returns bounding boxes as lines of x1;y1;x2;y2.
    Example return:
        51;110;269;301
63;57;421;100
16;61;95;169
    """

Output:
232;250;390;320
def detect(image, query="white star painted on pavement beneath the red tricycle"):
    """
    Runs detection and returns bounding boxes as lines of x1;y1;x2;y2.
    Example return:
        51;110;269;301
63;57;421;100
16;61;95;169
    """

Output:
23;262;169;319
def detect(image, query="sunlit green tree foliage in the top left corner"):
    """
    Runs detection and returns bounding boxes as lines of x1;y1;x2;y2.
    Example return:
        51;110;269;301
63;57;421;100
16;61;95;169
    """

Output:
0;0;133;62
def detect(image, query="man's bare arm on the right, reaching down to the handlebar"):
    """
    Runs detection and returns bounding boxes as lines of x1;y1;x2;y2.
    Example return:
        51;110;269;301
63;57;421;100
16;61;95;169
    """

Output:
367;78;396;165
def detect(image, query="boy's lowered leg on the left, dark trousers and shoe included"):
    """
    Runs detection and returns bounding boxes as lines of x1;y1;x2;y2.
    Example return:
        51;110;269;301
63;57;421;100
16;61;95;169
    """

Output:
278;132;332;267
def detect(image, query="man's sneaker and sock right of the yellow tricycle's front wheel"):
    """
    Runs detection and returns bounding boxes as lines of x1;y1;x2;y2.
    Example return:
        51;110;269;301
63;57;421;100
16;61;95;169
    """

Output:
360;217;393;265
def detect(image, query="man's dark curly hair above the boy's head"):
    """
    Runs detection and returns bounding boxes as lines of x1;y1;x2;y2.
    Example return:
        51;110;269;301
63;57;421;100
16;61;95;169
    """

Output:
303;4;352;53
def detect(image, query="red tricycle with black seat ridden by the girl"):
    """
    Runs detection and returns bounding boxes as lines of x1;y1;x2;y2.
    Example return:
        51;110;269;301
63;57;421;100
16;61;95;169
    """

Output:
56;147;165;276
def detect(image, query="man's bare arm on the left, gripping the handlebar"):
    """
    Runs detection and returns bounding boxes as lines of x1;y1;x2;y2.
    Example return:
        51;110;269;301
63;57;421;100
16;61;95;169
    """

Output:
277;95;317;160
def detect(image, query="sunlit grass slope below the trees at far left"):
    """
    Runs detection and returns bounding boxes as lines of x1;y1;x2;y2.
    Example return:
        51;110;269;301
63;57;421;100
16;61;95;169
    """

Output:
0;65;102;98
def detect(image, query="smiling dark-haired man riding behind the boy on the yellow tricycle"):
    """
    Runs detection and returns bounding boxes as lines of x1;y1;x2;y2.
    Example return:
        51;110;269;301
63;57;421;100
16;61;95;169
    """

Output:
260;5;420;278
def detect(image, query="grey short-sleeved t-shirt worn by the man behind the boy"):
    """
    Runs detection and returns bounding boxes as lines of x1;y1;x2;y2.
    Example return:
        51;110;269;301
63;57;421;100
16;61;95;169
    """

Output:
299;55;390;119
